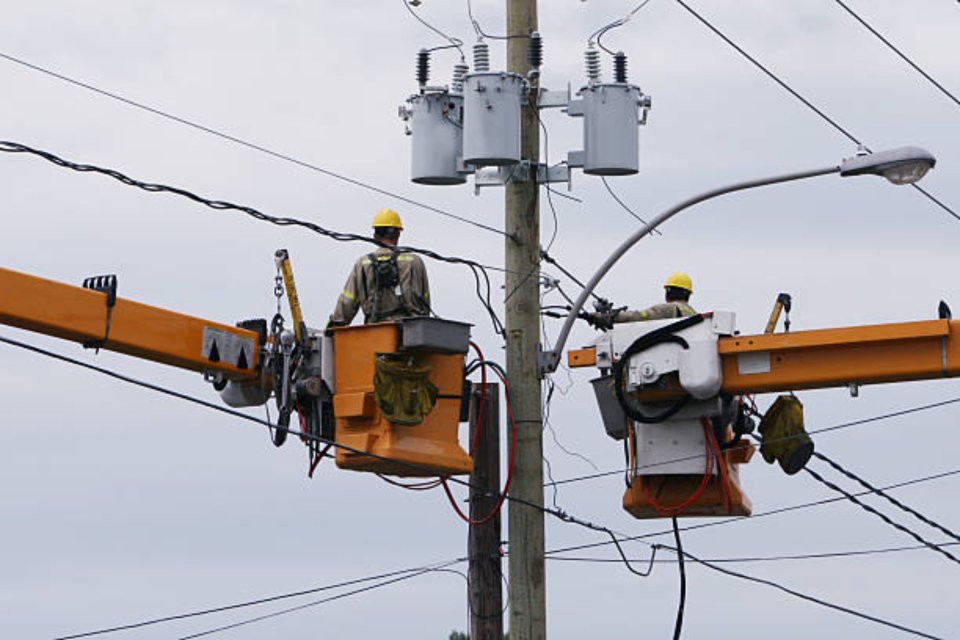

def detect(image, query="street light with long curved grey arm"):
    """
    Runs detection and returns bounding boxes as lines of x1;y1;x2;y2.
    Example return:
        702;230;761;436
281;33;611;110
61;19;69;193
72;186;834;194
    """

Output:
540;147;937;375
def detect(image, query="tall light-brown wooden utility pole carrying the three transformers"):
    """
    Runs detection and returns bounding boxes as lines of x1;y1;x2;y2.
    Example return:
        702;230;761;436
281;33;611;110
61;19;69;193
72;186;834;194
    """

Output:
504;0;547;640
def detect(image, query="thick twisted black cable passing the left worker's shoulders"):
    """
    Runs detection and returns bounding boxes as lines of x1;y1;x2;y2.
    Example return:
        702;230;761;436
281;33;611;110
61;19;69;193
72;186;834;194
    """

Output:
0;140;503;335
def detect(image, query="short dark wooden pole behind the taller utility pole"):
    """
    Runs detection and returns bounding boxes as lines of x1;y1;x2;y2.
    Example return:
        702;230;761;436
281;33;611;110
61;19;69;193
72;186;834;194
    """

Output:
467;384;503;640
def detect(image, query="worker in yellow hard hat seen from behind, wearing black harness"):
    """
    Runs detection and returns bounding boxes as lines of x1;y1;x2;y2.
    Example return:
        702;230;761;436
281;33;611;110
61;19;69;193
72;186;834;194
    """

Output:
330;209;430;326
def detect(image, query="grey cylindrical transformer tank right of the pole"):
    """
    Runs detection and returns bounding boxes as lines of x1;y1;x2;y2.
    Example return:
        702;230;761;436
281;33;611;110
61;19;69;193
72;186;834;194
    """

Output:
580;83;648;176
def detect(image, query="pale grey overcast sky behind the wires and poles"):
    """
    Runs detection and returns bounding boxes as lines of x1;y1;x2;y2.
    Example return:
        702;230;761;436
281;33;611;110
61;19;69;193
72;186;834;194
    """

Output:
0;0;960;640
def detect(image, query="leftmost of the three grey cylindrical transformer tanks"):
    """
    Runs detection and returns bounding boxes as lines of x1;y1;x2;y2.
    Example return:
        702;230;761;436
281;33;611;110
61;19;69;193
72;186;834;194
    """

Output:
406;91;467;185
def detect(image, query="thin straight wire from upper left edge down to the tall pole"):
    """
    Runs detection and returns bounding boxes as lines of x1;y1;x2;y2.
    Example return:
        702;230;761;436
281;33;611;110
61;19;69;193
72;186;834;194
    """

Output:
0;52;510;237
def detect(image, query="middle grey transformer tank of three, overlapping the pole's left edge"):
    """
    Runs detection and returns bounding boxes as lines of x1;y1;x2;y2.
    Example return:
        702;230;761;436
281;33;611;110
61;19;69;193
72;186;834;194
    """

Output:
463;72;527;166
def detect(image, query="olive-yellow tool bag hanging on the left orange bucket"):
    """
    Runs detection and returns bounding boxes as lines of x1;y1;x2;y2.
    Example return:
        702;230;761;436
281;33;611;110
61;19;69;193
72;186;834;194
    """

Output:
373;353;439;425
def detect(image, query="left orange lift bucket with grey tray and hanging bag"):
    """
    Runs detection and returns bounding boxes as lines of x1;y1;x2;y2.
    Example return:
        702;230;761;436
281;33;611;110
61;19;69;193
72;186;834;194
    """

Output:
333;318;473;476
